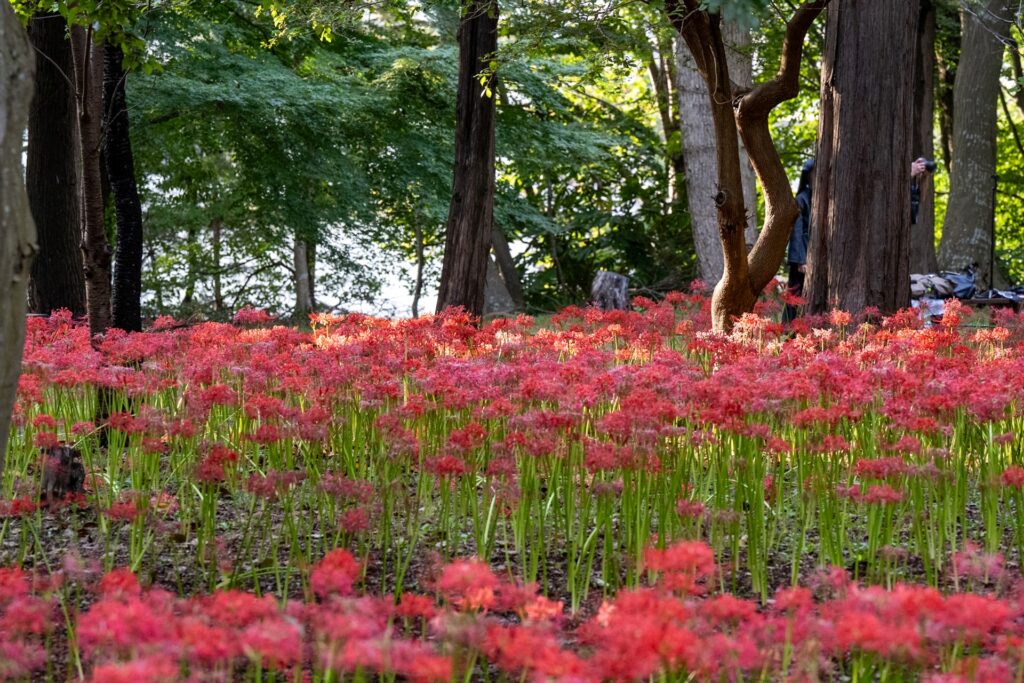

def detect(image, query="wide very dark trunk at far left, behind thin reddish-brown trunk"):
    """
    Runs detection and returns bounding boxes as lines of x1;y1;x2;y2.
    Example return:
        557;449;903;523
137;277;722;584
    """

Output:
25;13;85;315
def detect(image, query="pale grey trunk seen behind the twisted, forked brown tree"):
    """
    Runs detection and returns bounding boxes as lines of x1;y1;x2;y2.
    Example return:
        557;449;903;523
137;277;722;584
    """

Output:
677;23;757;285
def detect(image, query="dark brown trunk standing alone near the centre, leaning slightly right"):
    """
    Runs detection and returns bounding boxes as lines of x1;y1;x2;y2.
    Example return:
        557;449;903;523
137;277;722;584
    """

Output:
437;0;498;317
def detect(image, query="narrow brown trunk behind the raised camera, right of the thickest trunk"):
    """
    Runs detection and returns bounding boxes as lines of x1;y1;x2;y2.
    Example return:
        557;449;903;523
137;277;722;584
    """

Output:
910;0;939;272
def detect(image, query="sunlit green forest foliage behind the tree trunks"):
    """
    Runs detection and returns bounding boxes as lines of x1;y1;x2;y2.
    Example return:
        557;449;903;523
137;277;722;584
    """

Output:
16;0;1024;319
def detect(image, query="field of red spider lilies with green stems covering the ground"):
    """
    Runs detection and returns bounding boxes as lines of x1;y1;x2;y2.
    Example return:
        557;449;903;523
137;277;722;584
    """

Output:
0;286;1024;683
